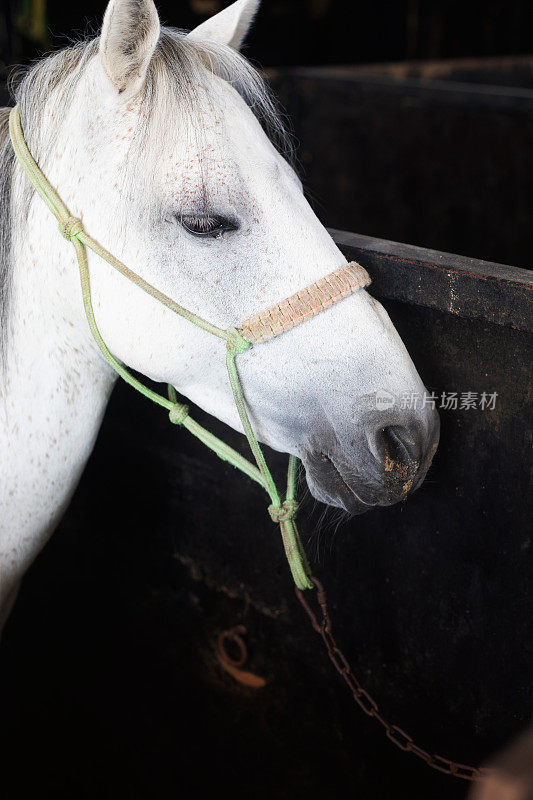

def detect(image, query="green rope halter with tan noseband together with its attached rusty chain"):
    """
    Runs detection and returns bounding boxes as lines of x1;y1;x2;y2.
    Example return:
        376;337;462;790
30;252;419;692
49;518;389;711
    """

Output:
9;106;490;781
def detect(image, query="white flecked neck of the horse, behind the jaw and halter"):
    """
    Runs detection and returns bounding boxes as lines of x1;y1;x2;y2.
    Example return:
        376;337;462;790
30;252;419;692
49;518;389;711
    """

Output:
0;168;114;617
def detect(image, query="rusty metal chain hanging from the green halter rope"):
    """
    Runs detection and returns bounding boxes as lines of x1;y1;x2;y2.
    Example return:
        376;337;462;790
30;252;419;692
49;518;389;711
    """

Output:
295;577;492;781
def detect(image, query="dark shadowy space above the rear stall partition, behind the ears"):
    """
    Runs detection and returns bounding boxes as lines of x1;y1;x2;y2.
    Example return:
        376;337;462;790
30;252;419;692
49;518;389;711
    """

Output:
2;0;533;67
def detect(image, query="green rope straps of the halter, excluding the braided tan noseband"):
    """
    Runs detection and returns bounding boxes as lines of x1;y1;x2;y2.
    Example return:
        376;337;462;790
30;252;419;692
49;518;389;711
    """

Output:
9;106;369;589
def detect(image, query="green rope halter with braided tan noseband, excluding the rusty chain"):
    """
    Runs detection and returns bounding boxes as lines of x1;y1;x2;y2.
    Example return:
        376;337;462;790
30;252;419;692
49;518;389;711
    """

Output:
9;106;370;589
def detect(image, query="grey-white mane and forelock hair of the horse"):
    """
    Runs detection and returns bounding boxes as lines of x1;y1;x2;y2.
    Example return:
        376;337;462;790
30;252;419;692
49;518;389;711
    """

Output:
0;28;292;367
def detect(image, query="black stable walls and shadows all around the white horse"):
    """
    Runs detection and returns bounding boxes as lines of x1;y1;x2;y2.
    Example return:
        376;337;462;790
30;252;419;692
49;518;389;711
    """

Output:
0;0;533;800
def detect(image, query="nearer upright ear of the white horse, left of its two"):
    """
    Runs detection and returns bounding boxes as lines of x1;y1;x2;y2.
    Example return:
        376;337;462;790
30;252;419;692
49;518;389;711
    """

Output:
100;0;160;95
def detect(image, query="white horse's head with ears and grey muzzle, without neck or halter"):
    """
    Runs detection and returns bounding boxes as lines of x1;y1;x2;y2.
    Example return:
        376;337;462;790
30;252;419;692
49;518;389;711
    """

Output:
14;0;439;513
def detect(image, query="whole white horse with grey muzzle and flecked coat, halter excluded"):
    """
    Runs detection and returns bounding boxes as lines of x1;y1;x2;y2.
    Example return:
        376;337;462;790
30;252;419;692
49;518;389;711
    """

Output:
0;0;438;628
